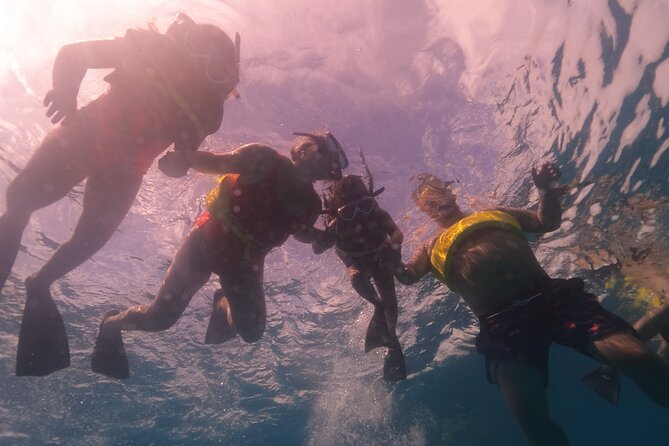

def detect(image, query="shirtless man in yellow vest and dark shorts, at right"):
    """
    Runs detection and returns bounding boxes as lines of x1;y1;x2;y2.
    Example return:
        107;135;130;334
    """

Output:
396;163;669;446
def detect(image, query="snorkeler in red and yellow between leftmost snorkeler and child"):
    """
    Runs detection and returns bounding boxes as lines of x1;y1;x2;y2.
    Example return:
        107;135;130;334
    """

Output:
91;132;348;378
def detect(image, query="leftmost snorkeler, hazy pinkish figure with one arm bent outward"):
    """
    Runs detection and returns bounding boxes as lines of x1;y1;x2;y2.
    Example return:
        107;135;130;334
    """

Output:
0;14;239;376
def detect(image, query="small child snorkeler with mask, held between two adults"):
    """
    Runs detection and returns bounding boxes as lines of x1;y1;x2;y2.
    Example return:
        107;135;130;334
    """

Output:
312;175;407;381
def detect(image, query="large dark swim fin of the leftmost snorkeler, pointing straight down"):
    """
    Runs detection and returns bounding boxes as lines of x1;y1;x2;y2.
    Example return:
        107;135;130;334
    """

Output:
16;283;70;376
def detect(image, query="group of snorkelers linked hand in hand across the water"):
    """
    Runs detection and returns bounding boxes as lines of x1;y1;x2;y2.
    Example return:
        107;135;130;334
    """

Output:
0;14;669;445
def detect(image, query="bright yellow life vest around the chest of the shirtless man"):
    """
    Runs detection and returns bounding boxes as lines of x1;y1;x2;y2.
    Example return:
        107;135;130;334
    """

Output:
430;211;525;290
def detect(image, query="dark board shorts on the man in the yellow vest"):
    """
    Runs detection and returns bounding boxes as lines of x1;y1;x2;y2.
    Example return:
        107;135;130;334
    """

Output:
476;278;638;384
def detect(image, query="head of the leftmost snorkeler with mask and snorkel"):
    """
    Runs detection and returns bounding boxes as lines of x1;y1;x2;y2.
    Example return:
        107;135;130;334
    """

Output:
165;12;241;99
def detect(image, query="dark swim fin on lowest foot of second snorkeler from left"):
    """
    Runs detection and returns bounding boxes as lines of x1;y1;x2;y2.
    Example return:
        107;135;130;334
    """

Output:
91;311;130;379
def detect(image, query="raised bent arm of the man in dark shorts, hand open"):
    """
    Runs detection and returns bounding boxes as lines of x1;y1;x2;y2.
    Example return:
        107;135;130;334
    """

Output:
498;162;565;234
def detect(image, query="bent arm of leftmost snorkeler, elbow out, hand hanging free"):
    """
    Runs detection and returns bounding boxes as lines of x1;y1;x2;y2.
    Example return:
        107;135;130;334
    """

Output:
44;39;123;124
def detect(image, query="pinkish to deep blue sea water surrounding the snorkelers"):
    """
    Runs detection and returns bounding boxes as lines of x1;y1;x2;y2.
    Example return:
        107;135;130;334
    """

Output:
0;0;669;445
